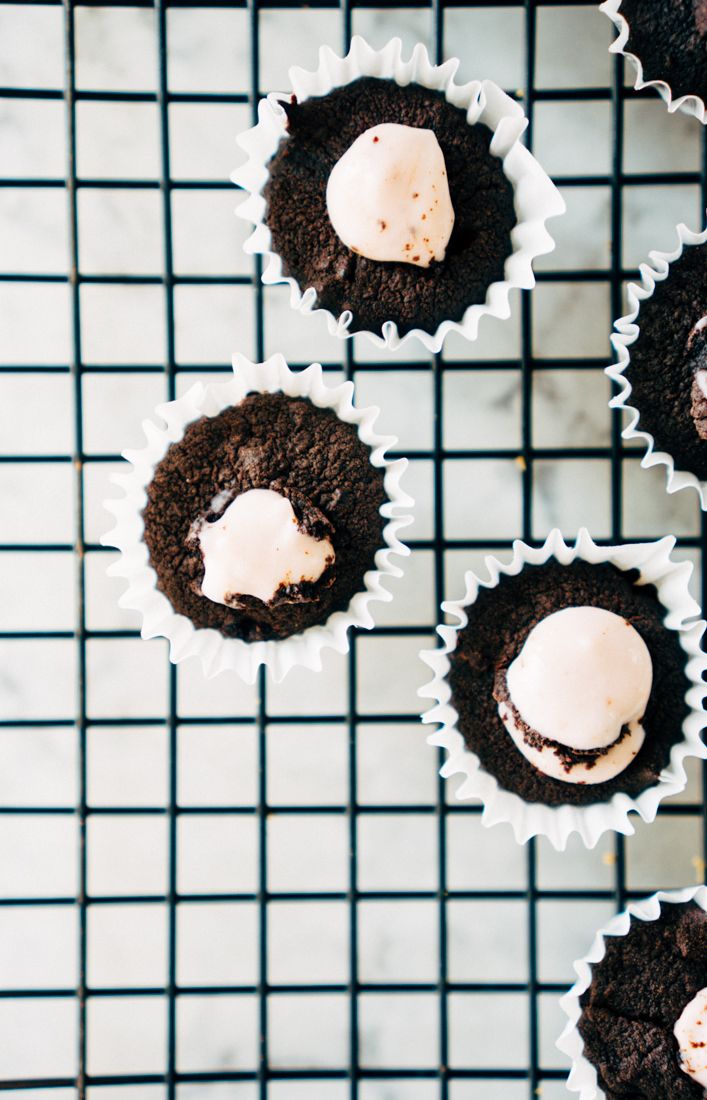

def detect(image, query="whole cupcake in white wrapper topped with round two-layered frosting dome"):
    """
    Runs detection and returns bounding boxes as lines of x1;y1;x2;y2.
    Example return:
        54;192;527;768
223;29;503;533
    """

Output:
420;529;707;849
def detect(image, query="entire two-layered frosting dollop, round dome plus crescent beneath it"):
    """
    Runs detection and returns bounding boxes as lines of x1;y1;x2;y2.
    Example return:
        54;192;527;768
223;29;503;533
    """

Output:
498;607;653;783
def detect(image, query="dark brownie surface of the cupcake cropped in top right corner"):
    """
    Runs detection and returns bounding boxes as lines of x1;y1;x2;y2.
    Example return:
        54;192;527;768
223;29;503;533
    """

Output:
620;0;707;100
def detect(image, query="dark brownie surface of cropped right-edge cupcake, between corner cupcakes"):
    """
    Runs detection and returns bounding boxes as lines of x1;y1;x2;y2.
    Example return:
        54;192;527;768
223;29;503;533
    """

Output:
626;244;707;480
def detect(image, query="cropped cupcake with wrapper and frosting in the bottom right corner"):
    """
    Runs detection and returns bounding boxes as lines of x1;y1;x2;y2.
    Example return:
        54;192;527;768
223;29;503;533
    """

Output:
557;886;707;1100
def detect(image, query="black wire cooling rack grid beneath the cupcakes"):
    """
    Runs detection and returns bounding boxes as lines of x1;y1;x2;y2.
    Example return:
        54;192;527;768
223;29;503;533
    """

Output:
0;0;707;1100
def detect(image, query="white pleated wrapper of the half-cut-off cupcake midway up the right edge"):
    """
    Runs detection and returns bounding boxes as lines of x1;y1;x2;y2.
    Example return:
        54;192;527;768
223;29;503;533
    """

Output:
606;224;707;510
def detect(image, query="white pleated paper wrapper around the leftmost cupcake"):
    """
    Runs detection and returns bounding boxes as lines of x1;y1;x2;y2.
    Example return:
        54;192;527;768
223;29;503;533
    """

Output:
101;355;412;683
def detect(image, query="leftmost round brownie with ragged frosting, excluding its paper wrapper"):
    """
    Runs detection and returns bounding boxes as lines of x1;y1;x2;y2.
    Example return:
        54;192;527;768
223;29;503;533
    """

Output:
143;393;386;641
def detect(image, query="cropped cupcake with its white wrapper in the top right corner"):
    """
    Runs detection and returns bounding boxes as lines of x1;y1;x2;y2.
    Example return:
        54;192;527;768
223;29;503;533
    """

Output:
599;0;707;123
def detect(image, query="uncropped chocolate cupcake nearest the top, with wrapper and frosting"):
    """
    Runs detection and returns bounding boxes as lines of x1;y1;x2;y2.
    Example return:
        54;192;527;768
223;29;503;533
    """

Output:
232;36;565;352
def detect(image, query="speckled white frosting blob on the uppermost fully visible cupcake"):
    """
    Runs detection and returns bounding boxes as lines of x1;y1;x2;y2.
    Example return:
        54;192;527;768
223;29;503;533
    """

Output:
327;122;454;267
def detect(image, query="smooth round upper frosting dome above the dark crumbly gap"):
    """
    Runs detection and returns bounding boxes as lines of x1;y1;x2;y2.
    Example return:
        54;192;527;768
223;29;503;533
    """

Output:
507;607;653;752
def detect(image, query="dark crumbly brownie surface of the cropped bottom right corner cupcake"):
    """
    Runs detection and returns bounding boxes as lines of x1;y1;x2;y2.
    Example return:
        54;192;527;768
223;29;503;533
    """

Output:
578;902;707;1100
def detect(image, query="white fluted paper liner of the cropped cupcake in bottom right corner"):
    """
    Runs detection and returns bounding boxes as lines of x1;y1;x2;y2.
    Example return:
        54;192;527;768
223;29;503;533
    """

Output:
555;886;707;1100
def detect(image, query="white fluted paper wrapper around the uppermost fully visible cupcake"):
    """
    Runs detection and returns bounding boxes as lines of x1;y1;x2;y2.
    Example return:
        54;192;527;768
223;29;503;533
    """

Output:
231;35;565;352
